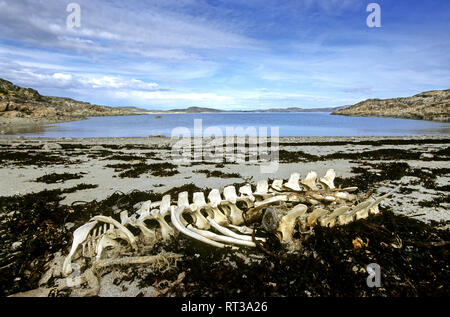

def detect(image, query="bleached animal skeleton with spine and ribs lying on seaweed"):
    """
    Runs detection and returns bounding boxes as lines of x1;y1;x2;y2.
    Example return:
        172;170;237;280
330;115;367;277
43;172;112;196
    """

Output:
63;169;395;276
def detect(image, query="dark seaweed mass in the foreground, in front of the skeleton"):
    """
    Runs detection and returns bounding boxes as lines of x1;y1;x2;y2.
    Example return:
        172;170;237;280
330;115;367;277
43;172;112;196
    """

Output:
136;210;450;297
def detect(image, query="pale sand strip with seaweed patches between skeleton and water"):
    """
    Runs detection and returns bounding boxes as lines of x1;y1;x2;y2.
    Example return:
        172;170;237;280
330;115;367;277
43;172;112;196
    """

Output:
0;137;450;221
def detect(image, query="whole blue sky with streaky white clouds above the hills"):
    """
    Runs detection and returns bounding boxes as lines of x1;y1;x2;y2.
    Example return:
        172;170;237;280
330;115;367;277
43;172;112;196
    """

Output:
0;0;450;110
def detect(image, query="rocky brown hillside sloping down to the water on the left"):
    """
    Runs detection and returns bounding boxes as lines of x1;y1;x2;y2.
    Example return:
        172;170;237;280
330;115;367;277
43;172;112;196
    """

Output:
0;79;149;124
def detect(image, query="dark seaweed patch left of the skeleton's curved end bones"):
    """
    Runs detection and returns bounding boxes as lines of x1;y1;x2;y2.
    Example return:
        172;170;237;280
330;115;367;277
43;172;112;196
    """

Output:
0;184;97;296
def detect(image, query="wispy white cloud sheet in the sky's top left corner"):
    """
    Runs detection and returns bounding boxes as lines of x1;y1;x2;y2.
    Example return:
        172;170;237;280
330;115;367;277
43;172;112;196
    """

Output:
0;0;261;60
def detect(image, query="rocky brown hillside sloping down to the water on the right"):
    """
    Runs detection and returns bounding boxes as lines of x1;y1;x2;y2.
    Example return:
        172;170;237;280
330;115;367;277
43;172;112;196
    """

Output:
332;89;450;122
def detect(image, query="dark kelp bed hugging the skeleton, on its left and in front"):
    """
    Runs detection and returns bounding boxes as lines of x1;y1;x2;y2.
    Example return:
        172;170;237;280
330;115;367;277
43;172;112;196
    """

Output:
0;184;450;296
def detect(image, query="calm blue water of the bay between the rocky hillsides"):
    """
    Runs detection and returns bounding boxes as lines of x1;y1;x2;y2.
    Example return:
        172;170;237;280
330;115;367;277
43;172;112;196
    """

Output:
10;113;450;138
